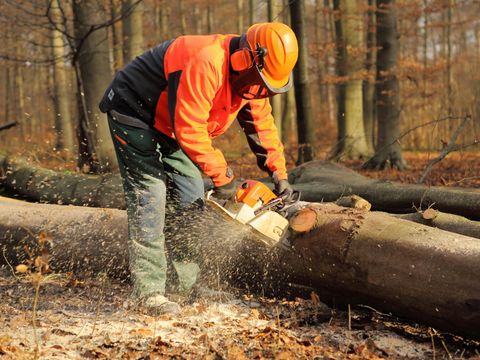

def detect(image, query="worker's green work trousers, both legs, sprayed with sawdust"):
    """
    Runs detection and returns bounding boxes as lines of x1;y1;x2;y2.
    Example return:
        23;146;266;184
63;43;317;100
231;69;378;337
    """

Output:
108;112;204;298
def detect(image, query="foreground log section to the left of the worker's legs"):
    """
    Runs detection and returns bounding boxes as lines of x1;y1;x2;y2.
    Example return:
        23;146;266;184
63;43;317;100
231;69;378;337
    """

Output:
0;197;128;277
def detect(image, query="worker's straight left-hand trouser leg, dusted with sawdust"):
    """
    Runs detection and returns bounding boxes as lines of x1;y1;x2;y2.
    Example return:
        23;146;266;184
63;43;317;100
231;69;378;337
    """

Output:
109;115;167;298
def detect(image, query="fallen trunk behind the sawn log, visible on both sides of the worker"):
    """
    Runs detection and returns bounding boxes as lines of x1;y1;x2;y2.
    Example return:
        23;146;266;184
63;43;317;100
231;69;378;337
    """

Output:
0;156;480;219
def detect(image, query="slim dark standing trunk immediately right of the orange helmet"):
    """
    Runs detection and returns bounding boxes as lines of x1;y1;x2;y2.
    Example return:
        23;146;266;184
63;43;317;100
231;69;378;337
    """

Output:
289;0;315;164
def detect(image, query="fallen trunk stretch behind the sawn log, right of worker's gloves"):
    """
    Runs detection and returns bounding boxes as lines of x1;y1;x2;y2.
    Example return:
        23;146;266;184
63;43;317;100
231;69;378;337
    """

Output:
289;161;480;219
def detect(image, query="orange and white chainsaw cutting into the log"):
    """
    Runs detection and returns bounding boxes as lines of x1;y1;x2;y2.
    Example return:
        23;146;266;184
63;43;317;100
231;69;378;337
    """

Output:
206;180;300;247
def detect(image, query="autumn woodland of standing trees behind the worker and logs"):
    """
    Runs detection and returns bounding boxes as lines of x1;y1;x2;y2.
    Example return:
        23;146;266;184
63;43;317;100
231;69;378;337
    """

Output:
0;0;480;184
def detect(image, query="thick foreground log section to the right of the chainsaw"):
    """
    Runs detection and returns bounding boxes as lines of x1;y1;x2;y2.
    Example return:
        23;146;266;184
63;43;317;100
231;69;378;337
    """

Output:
281;204;480;338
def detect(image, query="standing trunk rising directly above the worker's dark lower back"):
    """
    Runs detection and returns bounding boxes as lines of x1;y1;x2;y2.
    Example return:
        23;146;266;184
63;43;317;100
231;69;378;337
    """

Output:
122;0;144;63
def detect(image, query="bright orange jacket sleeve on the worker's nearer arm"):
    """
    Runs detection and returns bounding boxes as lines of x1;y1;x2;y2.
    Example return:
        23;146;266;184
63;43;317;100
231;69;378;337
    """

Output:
168;59;232;186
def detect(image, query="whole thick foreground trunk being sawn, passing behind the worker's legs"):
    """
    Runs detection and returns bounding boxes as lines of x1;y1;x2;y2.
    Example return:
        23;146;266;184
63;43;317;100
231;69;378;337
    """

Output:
0;198;480;338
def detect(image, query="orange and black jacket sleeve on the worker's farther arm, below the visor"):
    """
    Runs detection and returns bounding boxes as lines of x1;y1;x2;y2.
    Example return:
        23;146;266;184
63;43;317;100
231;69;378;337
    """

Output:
238;99;287;180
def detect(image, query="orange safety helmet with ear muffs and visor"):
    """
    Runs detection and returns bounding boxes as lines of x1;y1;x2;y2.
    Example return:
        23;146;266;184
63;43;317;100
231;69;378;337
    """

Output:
230;23;298;99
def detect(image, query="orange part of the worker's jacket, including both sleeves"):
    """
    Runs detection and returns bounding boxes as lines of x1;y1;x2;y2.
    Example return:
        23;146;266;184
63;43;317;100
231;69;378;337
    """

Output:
154;35;287;186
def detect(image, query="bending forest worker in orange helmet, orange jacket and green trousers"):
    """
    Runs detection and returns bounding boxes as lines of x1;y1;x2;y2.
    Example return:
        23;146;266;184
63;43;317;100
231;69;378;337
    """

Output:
100;23;298;313
